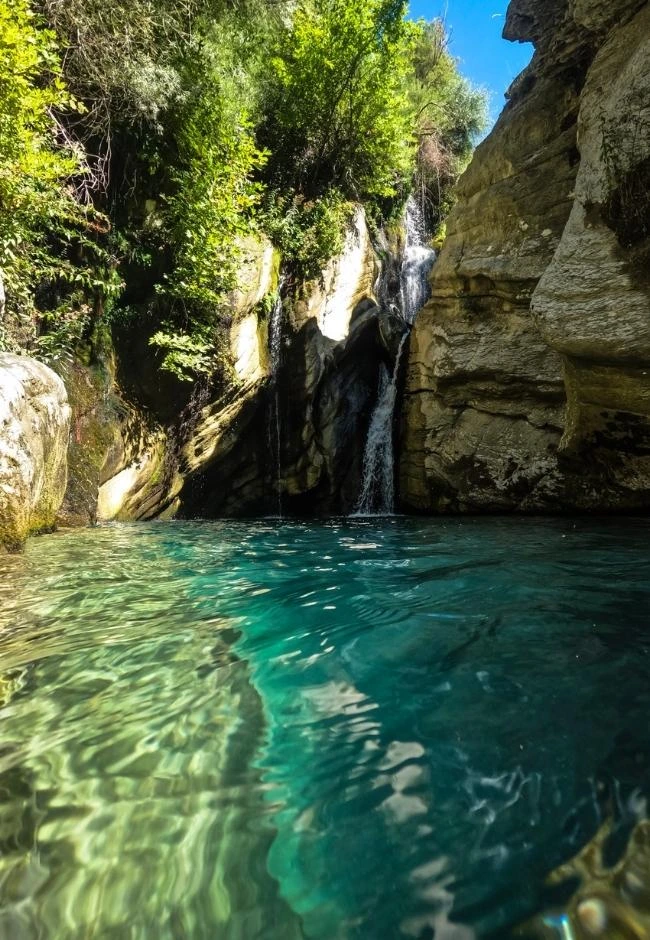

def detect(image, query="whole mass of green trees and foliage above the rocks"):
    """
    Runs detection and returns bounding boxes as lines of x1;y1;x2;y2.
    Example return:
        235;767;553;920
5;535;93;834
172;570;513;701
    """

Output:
0;0;484;379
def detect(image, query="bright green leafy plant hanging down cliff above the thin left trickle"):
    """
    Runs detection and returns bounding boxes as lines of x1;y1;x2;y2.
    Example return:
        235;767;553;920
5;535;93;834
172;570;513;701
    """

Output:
152;52;266;379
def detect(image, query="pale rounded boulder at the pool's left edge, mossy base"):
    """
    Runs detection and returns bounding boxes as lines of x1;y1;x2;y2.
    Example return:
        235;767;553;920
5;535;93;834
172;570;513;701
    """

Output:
0;353;70;551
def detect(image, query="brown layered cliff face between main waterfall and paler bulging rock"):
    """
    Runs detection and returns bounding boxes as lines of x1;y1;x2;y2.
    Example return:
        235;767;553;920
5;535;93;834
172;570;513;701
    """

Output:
400;36;578;511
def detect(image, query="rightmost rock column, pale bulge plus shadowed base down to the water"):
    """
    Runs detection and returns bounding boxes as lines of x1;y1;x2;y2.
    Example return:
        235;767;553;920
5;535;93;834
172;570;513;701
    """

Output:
532;3;650;496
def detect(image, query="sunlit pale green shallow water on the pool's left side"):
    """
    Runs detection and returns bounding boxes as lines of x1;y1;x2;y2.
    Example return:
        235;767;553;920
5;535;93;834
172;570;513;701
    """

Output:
0;529;300;940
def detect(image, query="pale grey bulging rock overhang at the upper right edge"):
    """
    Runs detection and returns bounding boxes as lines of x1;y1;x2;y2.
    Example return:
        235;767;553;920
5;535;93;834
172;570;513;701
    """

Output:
532;4;650;362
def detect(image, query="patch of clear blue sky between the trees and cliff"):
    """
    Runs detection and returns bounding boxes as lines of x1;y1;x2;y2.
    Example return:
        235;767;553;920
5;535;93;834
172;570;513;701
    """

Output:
411;0;533;120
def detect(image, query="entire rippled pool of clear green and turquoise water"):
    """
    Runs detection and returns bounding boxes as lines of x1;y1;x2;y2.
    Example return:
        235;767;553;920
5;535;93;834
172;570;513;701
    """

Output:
0;518;650;940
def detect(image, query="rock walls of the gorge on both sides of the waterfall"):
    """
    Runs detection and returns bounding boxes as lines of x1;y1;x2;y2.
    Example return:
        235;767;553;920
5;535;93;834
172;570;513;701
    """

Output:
3;0;650;543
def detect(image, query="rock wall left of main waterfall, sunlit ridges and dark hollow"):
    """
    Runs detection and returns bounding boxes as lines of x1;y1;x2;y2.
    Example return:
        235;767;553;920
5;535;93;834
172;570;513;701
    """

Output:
93;209;392;521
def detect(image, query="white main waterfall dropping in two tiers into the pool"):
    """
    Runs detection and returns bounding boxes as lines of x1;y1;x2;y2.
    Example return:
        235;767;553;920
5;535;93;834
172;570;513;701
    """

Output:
354;196;436;516
